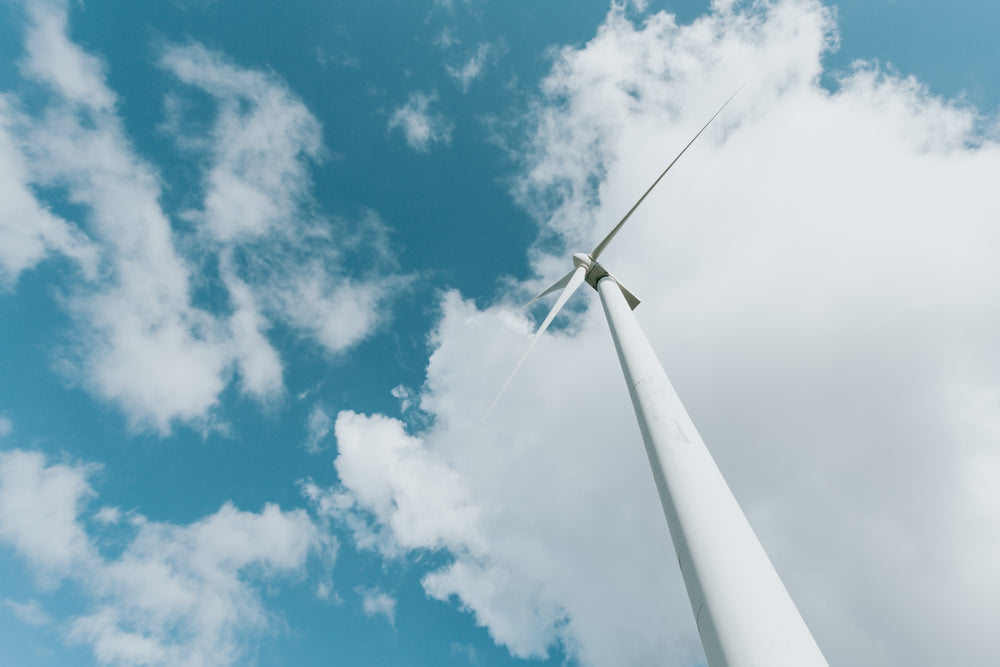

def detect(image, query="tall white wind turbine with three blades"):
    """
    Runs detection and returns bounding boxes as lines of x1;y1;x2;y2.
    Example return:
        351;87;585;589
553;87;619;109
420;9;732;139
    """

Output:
483;90;827;667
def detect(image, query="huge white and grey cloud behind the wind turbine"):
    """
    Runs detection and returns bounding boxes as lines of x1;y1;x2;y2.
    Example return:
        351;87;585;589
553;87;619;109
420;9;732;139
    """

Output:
314;0;1000;666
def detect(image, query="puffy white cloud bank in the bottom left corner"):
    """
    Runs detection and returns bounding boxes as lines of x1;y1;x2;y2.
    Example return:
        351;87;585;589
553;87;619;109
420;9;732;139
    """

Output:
0;450;337;665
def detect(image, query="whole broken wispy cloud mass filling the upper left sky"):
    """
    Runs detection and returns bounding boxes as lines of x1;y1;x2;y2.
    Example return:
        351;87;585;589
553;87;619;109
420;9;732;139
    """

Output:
0;1;395;433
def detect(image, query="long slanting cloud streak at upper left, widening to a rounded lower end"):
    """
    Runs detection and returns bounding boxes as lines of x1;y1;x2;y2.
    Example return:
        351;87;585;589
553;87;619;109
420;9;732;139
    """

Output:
14;3;236;432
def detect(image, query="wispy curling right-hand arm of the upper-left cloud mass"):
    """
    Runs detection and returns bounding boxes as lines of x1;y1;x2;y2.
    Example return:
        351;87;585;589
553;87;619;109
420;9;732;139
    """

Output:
161;44;395;360
